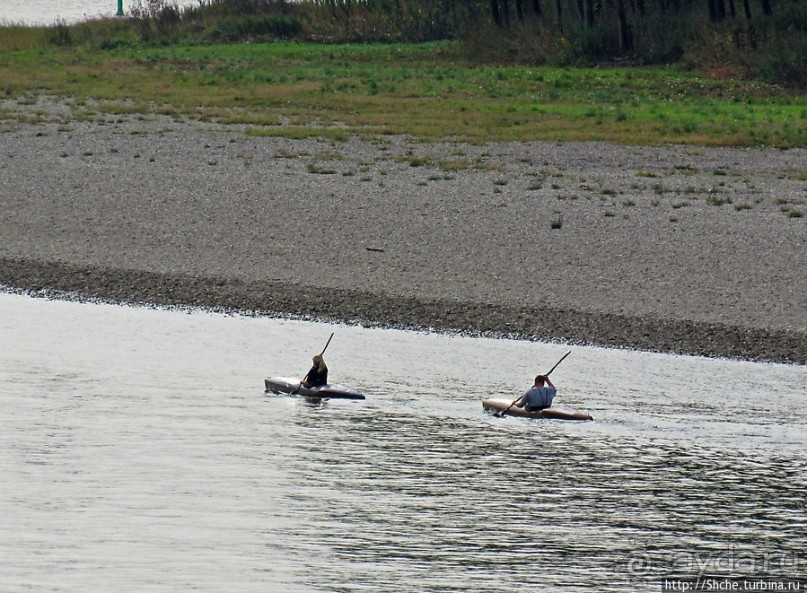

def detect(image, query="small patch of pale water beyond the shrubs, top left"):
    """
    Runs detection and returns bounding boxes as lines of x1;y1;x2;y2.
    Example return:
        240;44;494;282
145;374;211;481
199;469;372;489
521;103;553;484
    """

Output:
0;0;199;25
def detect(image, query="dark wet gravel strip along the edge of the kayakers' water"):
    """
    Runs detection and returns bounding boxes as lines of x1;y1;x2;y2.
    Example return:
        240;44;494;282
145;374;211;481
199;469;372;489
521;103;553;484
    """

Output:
0;259;807;365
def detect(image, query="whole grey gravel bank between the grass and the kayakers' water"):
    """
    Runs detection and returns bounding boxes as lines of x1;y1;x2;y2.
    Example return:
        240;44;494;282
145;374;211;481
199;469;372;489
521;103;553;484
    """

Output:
0;110;807;364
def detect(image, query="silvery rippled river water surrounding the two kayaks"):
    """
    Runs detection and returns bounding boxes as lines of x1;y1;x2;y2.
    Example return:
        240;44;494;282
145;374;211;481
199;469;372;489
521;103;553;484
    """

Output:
0;293;807;593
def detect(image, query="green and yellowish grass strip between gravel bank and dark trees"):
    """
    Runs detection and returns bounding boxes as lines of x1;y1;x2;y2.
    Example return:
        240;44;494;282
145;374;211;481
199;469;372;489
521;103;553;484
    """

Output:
0;37;807;147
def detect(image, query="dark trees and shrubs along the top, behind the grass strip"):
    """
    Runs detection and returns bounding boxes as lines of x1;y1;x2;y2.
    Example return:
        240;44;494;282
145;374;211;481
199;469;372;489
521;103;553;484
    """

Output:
0;0;807;89
